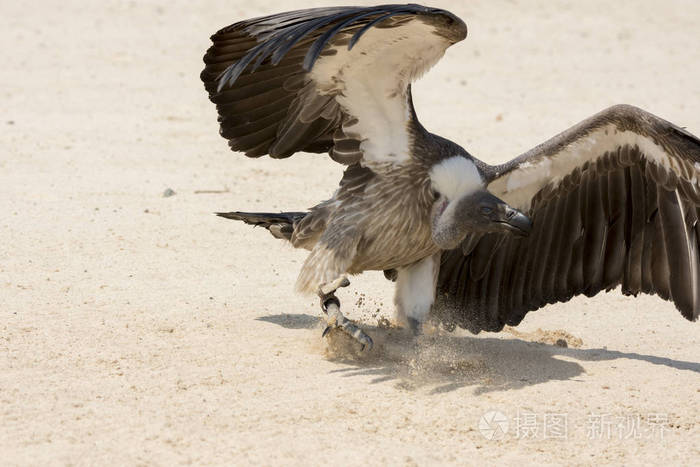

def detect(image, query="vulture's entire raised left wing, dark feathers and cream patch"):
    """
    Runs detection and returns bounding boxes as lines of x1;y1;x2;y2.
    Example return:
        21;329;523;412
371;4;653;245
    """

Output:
201;5;467;170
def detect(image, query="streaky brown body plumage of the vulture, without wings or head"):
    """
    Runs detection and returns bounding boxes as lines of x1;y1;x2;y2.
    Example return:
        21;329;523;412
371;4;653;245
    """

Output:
291;120;468;293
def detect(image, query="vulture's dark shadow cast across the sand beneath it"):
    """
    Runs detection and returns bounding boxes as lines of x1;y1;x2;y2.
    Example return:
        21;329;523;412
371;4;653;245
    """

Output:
258;314;700;394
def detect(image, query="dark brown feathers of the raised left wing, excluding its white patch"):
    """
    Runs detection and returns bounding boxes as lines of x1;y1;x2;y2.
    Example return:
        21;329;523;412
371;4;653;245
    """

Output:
201;4;466;165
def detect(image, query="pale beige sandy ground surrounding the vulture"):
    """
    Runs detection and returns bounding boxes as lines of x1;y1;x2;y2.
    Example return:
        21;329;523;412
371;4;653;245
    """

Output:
0;0;700;465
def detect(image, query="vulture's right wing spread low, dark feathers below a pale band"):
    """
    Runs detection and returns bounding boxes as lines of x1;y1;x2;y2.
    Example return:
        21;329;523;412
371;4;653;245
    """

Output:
436;106;700;332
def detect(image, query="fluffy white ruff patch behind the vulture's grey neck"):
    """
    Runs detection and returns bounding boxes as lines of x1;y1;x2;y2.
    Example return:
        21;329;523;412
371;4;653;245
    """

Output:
430;156;484;201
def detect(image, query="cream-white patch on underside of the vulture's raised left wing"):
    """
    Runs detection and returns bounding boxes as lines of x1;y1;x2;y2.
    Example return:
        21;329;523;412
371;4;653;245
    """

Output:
310;19;450;170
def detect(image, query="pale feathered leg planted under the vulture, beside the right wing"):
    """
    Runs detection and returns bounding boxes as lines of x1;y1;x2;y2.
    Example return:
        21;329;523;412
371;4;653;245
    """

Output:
394;253;441;335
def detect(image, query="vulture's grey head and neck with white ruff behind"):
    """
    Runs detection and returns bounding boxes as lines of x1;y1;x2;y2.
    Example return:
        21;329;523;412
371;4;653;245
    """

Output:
430;156;532;250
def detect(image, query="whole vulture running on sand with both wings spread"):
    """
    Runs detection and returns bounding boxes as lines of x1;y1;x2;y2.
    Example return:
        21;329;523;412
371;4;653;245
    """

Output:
201;4;700;349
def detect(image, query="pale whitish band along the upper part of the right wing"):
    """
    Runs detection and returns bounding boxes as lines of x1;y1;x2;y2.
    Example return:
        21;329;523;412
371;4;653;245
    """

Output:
488;124;679;211
